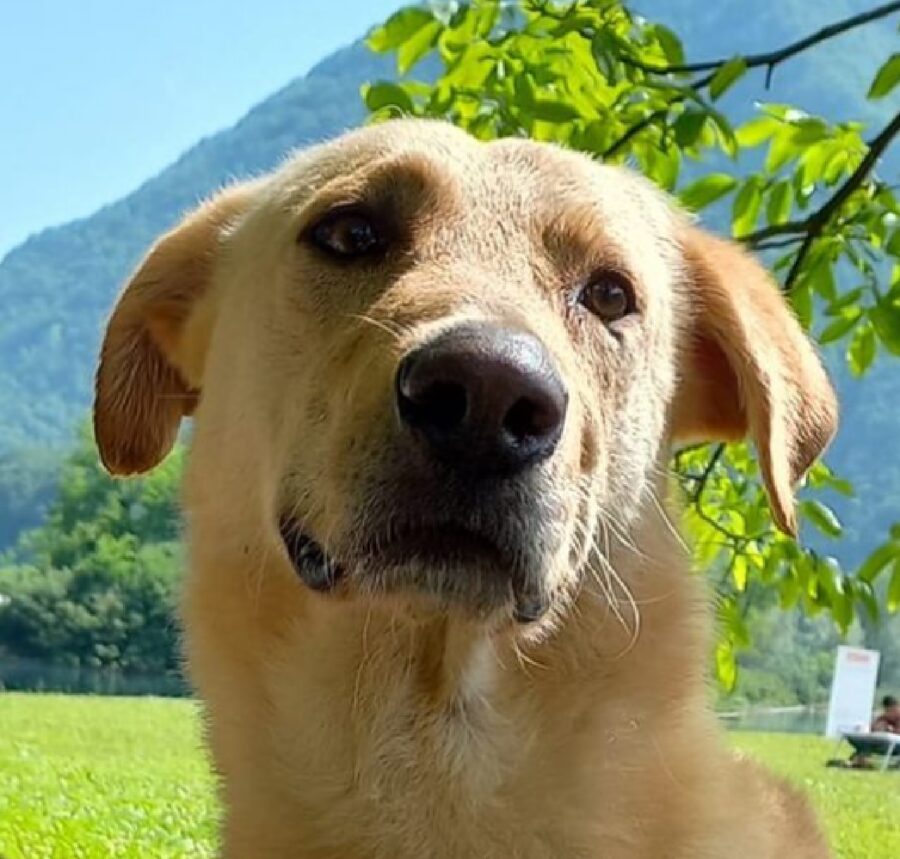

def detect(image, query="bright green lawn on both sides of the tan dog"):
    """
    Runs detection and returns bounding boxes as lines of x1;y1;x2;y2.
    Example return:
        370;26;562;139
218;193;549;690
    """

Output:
0;694;900;859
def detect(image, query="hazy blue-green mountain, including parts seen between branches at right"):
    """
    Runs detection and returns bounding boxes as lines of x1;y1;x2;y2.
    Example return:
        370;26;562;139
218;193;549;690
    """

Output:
0;5;900;556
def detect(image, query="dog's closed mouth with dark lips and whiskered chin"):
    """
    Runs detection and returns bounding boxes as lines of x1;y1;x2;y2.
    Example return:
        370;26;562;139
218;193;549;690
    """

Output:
279;517;551;624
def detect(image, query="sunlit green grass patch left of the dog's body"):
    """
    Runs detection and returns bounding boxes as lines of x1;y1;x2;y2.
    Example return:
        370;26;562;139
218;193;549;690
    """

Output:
0;694;216;859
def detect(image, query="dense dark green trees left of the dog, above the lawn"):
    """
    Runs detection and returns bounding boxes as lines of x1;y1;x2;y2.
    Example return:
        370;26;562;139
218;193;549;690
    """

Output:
0;433;181;674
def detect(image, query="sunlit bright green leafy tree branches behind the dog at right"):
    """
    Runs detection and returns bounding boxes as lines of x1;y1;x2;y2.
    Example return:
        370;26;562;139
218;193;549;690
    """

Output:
364;0;900;688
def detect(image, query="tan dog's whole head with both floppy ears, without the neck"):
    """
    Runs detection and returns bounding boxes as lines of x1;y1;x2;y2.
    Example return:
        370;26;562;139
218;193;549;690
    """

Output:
95;120;836;622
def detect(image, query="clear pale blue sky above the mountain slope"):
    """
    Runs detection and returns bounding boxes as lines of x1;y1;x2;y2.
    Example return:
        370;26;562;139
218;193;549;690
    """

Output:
0;0;403;257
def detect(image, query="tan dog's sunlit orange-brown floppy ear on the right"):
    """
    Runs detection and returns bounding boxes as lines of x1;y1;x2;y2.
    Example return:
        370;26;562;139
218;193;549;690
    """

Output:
672;227;837;534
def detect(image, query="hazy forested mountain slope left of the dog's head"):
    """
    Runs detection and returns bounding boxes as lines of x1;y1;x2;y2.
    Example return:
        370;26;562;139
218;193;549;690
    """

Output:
0;44;391;452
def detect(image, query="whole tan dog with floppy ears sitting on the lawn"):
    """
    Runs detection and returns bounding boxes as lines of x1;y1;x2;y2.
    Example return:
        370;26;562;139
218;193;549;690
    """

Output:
95;120;836;859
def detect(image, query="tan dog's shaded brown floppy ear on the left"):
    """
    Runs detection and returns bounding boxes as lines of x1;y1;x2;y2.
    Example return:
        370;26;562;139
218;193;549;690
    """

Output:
94;184;253;475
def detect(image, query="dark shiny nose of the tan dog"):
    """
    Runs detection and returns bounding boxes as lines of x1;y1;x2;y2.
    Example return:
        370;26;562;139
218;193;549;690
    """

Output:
397;323;568;474
